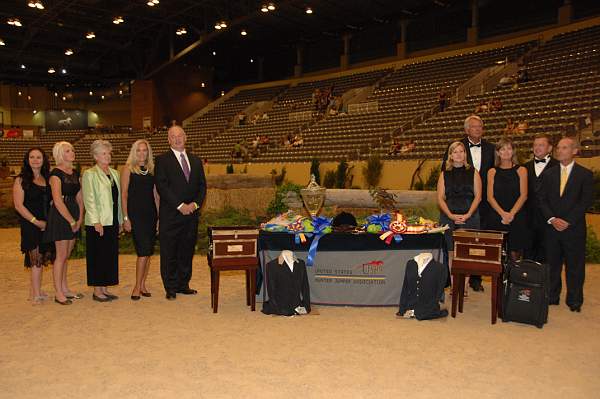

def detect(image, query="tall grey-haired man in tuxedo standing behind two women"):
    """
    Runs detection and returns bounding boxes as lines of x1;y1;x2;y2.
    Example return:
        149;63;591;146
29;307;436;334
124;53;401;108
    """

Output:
442;115;495;291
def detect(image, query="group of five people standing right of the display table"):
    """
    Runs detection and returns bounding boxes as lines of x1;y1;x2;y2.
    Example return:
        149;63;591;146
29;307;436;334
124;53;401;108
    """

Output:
437;115;593;312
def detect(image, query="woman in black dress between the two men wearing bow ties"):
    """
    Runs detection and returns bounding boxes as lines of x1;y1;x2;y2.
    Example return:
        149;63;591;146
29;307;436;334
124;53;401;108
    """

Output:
487;137;531;260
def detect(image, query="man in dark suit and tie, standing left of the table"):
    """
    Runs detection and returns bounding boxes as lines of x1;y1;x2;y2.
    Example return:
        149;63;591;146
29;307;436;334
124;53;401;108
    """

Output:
155;126;206;300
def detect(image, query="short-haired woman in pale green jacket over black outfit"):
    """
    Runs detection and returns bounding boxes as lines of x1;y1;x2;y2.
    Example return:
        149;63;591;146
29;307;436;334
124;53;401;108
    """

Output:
81;140;123;302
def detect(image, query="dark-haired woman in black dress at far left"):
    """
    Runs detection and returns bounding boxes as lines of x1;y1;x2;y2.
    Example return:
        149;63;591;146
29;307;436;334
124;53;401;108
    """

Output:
13;147;54;305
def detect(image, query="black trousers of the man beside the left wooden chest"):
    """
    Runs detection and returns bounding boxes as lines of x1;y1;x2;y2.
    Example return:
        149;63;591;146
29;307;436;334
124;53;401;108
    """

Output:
159;219;198;293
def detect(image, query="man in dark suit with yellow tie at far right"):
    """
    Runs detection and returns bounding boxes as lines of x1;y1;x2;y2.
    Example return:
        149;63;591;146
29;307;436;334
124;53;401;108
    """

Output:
539;137;594;312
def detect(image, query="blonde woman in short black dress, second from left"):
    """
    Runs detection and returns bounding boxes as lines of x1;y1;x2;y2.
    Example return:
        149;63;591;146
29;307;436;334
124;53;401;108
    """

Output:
43;141;83;305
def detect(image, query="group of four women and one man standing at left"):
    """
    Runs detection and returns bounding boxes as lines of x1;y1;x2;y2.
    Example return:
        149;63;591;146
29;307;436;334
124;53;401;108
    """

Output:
13;126;206;305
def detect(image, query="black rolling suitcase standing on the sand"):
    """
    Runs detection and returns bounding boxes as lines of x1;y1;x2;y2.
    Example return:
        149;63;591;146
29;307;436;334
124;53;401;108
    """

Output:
502;260;550;328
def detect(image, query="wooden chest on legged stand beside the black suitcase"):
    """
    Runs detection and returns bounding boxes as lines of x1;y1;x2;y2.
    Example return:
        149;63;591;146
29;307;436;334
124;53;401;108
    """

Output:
452;229;506;324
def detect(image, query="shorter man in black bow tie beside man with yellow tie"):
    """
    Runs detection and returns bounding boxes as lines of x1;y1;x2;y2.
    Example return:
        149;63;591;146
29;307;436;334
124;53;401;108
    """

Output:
524;133;559;263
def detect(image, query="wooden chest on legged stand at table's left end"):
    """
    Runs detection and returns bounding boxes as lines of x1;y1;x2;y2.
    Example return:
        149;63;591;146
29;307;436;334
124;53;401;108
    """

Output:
207;226;258;313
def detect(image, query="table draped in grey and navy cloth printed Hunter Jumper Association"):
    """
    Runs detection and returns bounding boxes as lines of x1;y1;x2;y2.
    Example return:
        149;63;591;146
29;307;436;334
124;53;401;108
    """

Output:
257;231;444;306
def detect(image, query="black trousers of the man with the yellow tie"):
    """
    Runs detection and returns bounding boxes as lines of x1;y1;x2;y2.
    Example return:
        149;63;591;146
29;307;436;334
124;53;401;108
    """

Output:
546;226;585;306
